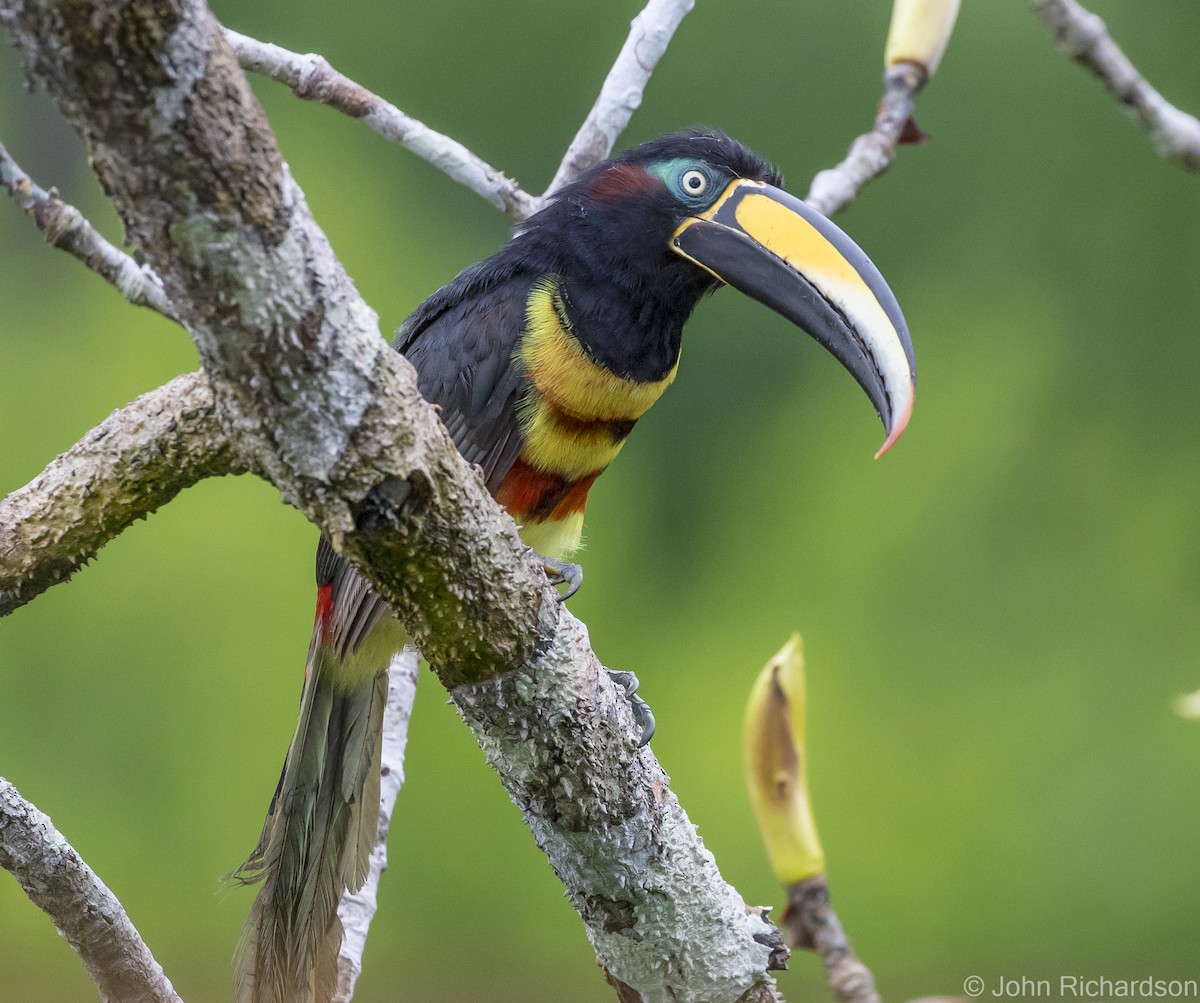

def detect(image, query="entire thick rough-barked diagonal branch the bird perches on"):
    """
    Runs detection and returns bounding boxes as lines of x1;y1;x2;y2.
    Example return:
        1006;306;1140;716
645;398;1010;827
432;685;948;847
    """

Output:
0;0;781;1003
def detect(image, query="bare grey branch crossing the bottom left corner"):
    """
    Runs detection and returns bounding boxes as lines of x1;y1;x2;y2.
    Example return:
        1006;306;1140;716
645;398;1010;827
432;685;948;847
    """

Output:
0;777;180;1003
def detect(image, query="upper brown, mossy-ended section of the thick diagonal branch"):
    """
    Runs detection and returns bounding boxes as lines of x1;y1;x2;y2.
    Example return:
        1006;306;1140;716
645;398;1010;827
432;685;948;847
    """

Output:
4;0;547;684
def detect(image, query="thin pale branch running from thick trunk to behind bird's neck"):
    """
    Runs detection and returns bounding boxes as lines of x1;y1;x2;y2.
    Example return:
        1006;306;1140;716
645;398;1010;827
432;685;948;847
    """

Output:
224;28;536;220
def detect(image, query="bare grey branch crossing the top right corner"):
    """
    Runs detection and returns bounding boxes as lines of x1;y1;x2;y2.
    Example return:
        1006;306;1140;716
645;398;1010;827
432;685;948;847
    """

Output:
1031;0;1200;172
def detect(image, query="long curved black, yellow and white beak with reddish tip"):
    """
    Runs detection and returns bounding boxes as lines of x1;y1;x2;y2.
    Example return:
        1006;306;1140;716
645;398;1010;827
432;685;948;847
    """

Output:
671;180;917;457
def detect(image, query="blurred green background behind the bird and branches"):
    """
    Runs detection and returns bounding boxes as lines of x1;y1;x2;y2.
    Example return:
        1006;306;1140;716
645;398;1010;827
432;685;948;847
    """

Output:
0;0;1200;1003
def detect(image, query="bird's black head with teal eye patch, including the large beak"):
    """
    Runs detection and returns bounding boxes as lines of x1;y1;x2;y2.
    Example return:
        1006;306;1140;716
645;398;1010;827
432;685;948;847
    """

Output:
534;130;916;456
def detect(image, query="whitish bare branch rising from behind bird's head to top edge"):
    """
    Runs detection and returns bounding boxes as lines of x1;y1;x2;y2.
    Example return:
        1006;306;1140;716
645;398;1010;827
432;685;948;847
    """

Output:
542;0;695;199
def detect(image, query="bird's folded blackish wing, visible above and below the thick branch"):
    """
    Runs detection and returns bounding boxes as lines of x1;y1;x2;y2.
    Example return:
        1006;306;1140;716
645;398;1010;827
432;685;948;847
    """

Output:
317;260;535;659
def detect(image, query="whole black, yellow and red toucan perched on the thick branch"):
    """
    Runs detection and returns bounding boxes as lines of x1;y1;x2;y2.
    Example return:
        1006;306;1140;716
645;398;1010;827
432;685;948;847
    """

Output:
235;128;916;1003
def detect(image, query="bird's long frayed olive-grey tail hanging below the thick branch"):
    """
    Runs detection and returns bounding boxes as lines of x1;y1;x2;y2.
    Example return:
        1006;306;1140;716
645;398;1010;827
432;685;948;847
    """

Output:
232;621;388;1003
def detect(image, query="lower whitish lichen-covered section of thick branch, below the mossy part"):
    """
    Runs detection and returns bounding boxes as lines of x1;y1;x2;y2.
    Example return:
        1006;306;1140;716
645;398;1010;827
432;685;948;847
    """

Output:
451;609;787;1003
